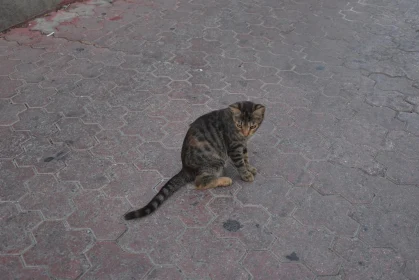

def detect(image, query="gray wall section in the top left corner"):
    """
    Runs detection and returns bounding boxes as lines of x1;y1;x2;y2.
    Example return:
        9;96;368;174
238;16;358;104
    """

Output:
0;0;64;31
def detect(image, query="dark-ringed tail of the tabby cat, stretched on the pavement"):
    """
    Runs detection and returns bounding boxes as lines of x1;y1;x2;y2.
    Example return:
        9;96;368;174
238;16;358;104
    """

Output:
124;169;193;220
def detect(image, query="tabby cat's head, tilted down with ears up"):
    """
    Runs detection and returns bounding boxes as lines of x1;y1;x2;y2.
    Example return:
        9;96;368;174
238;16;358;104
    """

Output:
228;101;265;137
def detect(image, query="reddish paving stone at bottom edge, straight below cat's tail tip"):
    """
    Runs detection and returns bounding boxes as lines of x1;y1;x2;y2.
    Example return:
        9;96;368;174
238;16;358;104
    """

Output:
83;241;153;279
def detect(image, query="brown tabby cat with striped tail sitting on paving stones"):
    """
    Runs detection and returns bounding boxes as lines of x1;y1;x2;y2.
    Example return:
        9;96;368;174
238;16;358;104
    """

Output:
124;101;265;220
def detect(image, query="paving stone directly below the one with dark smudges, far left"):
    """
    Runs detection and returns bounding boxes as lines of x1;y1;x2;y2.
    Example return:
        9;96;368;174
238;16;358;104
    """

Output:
19;174;78;220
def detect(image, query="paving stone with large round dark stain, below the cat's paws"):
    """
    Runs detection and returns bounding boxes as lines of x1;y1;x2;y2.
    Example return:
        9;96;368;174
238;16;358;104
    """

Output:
209;197;273;250
